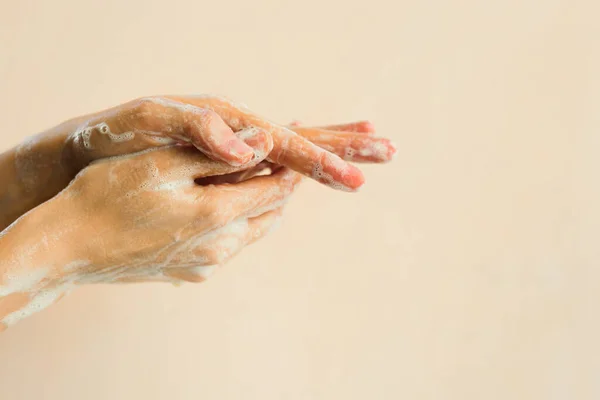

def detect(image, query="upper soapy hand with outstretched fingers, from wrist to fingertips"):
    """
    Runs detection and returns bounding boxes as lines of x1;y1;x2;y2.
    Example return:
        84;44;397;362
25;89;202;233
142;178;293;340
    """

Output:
64;96;395;191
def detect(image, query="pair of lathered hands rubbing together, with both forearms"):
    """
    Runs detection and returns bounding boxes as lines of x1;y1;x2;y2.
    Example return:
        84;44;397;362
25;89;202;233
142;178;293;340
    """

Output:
0;96;395;331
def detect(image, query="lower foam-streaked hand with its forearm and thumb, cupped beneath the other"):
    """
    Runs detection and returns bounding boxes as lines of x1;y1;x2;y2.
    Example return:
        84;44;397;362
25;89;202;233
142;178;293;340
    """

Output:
0;128;301;330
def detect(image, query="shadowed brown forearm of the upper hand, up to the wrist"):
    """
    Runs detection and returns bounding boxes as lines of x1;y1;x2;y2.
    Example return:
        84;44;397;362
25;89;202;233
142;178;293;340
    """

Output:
0;127;75;231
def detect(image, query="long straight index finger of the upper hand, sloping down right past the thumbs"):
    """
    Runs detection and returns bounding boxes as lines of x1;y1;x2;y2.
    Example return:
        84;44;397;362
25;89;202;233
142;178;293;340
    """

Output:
167;96;364;191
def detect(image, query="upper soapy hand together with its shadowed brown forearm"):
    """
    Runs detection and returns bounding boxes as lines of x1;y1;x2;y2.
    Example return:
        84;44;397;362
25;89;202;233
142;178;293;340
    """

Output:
0;96;395;230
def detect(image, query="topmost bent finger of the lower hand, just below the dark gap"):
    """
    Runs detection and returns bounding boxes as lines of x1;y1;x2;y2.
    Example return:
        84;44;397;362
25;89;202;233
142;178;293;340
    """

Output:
198;168;302;229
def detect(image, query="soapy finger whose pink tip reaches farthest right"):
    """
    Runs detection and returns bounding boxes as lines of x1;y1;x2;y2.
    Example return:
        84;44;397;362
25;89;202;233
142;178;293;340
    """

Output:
288;127;396;163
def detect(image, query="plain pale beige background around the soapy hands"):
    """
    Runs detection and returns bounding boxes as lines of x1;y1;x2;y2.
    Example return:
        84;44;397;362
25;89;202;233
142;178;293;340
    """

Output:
0;0;600;400
